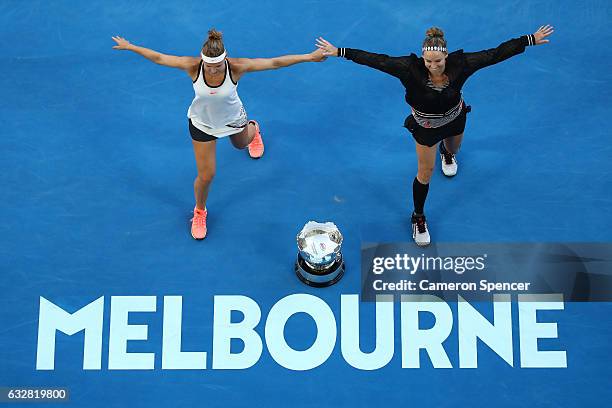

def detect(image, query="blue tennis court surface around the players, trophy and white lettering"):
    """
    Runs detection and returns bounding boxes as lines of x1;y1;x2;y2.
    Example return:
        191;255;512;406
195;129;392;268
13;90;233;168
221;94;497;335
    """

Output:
0;0;612;407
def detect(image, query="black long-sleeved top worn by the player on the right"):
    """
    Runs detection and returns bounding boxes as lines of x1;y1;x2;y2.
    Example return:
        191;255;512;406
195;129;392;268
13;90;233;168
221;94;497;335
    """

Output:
338;35;535;113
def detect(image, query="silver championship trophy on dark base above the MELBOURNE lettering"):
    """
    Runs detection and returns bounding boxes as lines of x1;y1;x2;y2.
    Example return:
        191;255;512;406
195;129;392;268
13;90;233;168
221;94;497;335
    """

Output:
295;221;344;287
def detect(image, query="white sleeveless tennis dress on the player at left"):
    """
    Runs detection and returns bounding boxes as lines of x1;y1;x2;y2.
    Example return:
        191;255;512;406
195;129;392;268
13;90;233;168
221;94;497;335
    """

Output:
187;60;247;137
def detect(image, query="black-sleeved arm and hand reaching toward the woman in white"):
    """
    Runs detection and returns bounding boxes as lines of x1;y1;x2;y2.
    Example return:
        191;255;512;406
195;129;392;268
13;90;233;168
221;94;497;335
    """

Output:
317;37;411;77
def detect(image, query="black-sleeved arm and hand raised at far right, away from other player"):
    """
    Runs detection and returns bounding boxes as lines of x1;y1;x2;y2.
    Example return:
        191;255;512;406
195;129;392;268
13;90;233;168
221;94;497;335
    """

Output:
464;25;554;73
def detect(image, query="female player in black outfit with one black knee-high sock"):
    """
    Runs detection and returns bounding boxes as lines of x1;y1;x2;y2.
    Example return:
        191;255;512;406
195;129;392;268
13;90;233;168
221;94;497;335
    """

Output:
317;25;553;246
